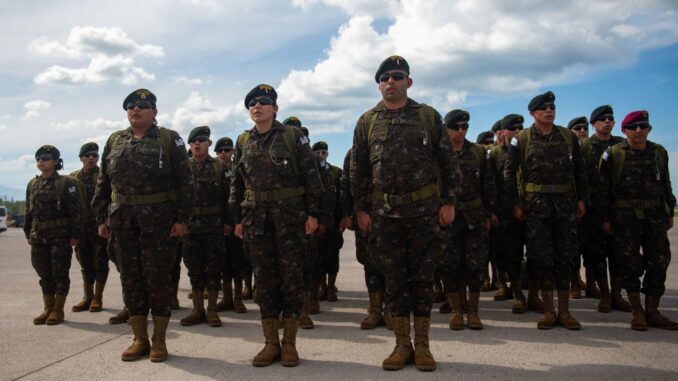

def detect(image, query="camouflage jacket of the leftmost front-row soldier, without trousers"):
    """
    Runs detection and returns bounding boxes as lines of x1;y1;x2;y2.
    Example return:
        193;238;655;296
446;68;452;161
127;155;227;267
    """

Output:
92;125;194;228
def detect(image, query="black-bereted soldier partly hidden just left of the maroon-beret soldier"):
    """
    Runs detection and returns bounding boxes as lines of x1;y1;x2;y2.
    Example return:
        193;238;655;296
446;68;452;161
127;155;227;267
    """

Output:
582;105;631;313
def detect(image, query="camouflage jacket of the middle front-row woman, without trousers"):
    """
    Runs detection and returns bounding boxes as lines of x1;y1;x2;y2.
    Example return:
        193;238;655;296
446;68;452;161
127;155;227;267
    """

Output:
229;120;323;224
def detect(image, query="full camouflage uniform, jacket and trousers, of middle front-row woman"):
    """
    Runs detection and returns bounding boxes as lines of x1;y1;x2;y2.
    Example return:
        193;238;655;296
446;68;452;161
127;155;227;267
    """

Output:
229;121;322;319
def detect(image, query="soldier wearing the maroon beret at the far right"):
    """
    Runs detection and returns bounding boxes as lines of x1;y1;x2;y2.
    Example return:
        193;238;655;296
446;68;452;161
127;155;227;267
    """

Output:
598;110;678;331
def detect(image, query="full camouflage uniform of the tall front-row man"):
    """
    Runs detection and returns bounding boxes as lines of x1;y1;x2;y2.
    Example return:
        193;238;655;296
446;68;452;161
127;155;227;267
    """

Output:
350;99;460;318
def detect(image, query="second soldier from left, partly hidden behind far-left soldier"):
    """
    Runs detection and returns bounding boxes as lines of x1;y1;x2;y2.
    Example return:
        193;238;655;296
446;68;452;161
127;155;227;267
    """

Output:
70;142;108;312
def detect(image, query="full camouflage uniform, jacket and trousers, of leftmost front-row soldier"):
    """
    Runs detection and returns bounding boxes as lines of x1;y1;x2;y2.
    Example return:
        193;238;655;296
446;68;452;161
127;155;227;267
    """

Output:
92;124;194;317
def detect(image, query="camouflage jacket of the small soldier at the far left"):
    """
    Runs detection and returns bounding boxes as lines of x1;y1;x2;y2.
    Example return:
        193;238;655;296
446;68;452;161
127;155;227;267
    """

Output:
24;172;81;240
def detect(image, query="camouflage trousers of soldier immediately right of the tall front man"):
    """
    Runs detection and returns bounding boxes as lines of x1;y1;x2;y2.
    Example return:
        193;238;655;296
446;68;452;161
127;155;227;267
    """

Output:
438;213;489;292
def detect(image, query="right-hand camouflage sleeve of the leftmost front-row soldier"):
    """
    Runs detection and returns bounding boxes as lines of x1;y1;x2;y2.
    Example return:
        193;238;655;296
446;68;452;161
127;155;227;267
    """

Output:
170;131;195;224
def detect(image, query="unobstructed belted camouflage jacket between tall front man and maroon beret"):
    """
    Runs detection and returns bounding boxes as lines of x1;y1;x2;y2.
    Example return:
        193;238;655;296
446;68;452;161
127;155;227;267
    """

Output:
504;124;587;218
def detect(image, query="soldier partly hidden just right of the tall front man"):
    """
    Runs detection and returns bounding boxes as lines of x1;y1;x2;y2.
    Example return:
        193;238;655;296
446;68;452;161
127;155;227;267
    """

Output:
440;110;497;330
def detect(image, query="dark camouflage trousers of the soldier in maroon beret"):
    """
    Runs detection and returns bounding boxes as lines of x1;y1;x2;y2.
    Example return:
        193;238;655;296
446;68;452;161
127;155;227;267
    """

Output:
612;209;671;296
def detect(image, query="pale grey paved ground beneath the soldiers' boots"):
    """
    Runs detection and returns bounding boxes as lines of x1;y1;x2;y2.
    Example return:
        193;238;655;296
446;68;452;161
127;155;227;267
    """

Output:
0;229;678;381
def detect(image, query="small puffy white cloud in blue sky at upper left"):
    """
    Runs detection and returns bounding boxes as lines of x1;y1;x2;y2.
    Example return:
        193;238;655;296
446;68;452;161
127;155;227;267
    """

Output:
28;26;165;85
